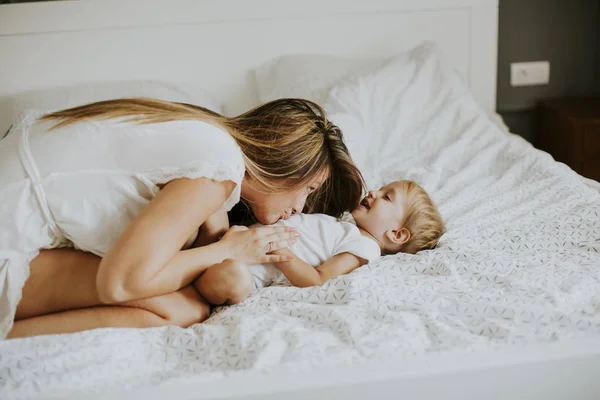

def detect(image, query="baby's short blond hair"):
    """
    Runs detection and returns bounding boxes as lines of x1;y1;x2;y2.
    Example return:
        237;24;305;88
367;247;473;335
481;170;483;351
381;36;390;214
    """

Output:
399;180;446;254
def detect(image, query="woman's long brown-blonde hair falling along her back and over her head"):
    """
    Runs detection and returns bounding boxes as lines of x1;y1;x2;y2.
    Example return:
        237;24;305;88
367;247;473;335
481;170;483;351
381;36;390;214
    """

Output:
41;98;364;217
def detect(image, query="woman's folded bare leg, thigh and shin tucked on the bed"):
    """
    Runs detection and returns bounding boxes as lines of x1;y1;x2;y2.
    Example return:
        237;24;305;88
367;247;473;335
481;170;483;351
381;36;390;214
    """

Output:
8;249;210;337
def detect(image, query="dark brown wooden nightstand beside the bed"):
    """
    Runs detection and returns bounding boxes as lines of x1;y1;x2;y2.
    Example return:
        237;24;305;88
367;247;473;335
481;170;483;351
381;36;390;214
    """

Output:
535;97;600;181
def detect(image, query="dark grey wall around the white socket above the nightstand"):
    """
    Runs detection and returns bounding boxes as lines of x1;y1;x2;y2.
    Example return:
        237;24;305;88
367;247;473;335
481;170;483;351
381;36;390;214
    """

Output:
497;0;600;141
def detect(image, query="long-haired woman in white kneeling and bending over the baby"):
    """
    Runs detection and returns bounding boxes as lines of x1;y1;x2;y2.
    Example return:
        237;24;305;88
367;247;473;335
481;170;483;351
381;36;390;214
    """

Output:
0;99;363;337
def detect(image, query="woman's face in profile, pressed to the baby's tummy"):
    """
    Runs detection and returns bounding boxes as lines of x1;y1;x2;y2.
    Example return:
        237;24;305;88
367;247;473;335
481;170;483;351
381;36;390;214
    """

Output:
242;171;329;225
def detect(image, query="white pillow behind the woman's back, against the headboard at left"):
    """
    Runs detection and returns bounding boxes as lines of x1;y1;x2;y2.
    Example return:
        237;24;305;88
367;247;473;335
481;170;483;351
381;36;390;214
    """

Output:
6;80;222;138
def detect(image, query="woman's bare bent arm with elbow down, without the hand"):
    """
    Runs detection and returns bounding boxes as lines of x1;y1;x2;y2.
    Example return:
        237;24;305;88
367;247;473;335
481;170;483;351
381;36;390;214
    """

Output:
96;178;235;303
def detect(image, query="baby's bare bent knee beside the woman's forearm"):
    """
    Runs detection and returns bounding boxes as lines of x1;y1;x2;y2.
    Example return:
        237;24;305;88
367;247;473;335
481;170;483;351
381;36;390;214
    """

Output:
194;259;254;305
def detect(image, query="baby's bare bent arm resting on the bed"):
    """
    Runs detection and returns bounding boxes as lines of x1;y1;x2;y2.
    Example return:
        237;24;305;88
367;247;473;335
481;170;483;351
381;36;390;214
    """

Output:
274;249;367;287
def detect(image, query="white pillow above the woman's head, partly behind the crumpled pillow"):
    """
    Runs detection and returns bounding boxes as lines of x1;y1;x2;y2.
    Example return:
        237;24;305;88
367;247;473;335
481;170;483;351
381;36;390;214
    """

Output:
254;54;386;105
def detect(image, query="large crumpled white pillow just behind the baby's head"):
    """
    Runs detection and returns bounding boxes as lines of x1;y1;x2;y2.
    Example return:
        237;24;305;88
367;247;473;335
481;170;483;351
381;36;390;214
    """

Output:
324;42;487;188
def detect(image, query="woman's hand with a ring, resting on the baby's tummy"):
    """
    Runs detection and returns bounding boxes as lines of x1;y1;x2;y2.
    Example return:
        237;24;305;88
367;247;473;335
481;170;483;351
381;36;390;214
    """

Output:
221;226;298;265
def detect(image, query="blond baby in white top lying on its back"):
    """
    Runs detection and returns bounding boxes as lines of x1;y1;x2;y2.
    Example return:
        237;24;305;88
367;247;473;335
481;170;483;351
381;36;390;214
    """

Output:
250;180;445;288
